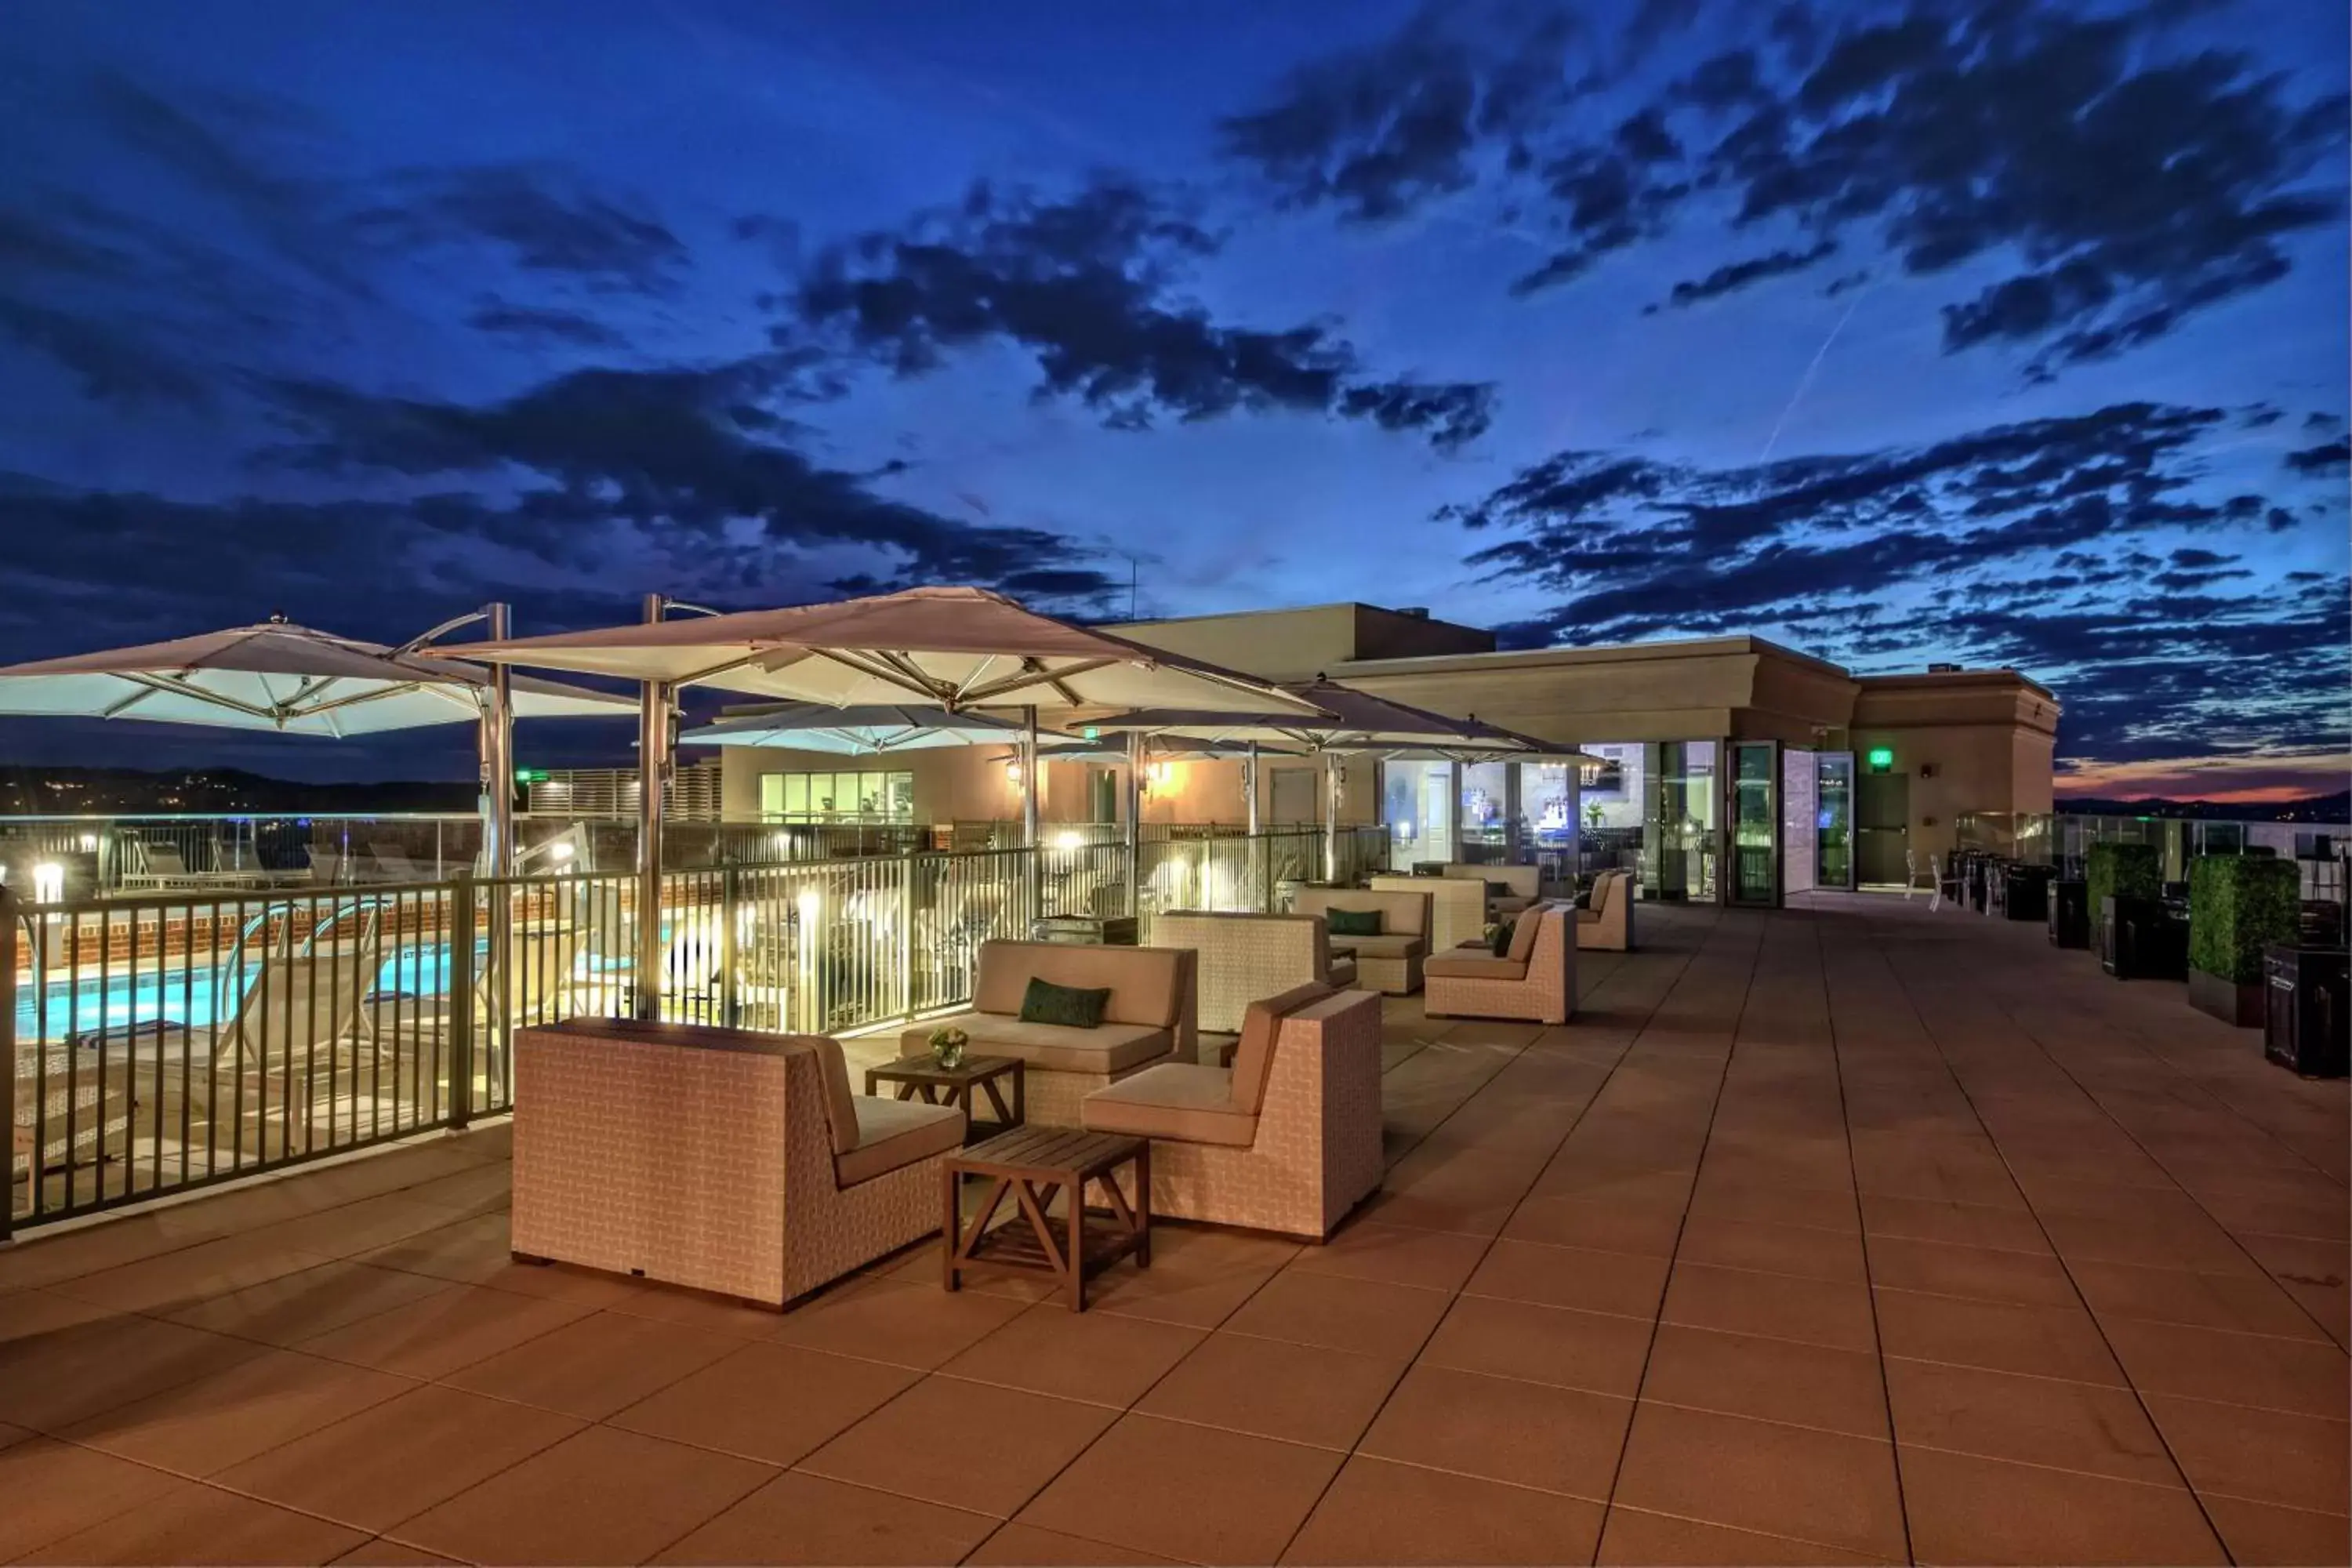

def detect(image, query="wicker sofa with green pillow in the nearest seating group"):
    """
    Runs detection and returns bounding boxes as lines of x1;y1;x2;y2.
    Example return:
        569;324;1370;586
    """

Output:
901;942;1200;1126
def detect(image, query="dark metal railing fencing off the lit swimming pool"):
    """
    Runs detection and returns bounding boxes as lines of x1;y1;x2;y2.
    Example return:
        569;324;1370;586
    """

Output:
0;827;1385;1239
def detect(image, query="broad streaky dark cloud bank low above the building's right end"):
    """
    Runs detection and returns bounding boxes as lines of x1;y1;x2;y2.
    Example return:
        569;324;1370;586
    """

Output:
1444;405;2347;760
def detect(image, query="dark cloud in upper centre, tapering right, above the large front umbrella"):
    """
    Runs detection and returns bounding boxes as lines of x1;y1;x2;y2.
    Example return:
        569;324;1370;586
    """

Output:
779;179;1494;449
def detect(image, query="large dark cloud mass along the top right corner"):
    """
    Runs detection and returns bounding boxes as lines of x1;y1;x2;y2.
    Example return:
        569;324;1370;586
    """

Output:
1228;0;2345;379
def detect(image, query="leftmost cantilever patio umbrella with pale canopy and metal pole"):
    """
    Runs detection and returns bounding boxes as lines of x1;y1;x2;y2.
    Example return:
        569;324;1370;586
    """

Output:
0;604;633;874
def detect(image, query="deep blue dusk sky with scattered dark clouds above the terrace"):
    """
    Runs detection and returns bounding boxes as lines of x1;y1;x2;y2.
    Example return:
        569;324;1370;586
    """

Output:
0;0;2352;799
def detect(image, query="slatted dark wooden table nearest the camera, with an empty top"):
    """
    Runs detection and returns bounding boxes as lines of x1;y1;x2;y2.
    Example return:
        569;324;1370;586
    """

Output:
938;1126;1152;1312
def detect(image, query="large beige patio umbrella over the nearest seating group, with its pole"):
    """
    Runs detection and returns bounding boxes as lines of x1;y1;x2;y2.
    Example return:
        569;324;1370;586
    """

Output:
449;588;1315;1015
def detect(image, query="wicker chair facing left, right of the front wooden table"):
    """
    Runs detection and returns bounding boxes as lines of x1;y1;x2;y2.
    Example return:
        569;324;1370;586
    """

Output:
1082;985;1383;1241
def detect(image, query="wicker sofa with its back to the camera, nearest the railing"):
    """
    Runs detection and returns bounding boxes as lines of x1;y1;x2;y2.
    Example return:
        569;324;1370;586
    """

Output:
513;1018;964;1309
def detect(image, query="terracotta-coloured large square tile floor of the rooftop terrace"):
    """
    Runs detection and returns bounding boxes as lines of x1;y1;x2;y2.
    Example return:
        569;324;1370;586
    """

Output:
0;895;2352;1563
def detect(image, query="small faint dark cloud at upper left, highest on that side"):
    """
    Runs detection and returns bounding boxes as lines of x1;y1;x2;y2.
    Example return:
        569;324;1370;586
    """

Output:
348;162;687;294
